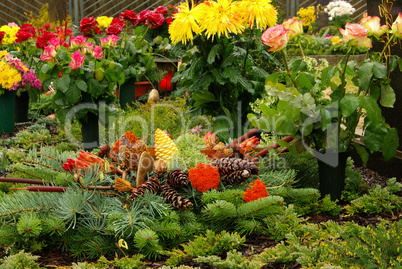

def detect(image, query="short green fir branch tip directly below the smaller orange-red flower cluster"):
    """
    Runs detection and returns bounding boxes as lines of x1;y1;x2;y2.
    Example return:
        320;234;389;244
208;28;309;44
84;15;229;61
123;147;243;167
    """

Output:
237;196;283;219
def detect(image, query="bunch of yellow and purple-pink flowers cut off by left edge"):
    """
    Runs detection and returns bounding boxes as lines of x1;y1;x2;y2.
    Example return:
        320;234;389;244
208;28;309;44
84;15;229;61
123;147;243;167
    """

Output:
0;51;42;96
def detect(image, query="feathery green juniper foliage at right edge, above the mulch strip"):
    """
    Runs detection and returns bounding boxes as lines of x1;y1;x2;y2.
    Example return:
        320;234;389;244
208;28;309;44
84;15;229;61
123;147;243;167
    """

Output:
346;178;402;215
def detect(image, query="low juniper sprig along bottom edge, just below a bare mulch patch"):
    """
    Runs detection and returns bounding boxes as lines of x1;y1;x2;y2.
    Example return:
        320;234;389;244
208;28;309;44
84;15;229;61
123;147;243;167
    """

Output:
194;250;264;269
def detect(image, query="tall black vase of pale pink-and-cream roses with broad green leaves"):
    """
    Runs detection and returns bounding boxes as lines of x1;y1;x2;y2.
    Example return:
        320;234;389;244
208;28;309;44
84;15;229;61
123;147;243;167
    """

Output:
249;15;402;199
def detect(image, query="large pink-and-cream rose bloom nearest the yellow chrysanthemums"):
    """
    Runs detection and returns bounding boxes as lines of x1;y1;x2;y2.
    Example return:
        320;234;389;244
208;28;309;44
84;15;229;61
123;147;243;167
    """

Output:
261;24;289;51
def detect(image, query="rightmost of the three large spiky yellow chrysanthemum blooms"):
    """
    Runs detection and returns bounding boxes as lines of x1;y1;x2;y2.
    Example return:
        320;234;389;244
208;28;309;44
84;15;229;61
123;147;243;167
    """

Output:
237;0;278;29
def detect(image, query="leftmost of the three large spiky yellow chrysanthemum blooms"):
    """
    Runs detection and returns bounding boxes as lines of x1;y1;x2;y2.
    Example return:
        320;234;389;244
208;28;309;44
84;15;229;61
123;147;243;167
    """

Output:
169;2;200;44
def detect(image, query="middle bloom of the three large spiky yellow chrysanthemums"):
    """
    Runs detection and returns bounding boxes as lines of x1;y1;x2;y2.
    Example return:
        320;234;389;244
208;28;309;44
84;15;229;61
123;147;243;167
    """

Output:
194;0;244;38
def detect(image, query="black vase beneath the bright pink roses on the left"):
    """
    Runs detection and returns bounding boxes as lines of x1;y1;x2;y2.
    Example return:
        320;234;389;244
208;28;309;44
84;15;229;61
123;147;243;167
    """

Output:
80;111;99;151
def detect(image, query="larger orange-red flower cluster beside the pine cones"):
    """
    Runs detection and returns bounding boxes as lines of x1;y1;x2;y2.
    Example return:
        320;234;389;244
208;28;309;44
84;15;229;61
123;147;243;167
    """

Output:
188;163;220;192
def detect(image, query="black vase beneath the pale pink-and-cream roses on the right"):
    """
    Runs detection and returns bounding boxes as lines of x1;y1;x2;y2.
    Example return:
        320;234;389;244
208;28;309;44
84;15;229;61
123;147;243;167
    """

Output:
314;151;351;201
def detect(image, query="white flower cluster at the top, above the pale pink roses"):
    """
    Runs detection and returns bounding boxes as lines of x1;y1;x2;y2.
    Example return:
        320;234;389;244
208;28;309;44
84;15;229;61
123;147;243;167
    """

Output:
324;0;356;28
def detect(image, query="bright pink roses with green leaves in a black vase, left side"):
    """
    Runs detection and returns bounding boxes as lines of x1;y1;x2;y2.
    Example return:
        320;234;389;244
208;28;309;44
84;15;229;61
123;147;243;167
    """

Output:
40;36;125;149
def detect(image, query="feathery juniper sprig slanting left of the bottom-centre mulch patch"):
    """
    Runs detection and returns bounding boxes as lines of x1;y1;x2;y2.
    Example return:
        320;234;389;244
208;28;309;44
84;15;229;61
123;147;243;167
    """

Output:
163;230;245;266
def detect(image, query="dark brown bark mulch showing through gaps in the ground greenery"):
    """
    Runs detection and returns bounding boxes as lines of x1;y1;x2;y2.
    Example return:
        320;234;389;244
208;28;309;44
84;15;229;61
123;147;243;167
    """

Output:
0;123;402;269
